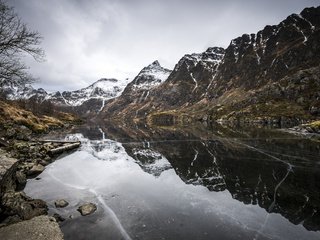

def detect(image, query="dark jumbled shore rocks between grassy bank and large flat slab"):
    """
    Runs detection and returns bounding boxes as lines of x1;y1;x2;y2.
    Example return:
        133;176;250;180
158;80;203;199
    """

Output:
0;140;80;225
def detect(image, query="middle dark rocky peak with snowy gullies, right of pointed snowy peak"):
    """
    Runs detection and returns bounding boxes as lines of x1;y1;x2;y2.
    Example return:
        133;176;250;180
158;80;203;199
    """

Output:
153;47;225;108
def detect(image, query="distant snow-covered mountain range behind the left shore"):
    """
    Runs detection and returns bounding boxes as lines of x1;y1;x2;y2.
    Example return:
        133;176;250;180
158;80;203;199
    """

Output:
1;78;127;116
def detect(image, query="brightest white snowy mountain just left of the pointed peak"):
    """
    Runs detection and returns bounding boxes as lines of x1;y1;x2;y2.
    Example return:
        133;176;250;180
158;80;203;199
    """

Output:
45;78;126;106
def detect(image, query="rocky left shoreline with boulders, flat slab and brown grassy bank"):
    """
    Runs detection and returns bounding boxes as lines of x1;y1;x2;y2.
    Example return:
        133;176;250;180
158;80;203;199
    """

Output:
0;125;81;239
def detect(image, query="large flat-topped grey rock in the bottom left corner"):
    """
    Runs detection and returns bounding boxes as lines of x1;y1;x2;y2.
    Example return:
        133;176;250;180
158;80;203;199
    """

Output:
0;216;63;240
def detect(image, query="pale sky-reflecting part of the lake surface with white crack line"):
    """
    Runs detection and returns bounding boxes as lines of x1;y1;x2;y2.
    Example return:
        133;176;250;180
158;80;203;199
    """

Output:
25;142;319;240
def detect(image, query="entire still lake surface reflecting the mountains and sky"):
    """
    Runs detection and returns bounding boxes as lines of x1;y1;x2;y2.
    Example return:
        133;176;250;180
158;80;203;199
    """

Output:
25;124;320;240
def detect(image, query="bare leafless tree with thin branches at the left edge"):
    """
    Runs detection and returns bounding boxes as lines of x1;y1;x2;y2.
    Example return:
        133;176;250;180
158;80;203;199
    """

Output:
0;0;44;85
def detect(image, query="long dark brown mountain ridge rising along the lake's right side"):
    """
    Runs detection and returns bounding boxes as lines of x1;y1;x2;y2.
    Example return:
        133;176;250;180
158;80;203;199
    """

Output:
100;7;320;125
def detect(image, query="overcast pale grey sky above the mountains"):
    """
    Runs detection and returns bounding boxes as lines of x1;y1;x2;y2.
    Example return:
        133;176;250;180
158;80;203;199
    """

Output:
6;0;320;91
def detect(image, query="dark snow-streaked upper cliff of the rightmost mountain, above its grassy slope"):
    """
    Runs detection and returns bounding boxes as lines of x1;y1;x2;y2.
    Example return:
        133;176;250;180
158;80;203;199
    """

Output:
210;7;320;106
